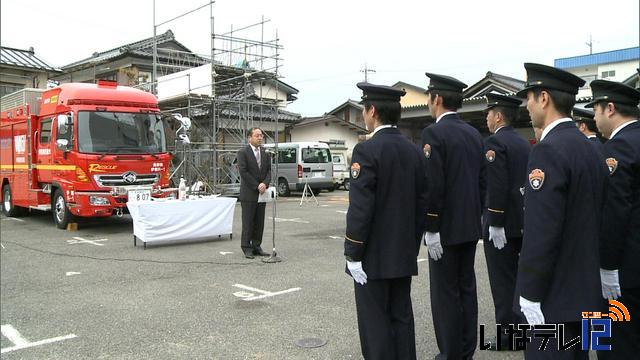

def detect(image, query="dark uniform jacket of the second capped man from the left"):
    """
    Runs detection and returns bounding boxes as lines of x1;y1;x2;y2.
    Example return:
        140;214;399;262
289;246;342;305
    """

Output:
422;114;486;245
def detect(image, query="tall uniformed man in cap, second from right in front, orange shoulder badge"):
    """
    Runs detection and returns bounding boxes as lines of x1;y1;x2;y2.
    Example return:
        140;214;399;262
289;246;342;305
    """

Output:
516;63;608;359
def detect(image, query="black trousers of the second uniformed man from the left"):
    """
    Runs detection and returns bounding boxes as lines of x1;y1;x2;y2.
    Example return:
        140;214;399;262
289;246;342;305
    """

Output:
429;241;478;359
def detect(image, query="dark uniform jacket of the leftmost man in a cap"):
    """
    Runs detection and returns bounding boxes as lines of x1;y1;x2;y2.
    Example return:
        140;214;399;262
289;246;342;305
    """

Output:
344;128;426;280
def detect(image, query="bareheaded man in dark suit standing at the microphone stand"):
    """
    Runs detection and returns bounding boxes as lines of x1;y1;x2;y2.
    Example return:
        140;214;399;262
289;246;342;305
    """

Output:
237;127;271;259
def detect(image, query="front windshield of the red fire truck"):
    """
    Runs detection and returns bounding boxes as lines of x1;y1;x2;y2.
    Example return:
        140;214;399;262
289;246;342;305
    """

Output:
78;111;167;154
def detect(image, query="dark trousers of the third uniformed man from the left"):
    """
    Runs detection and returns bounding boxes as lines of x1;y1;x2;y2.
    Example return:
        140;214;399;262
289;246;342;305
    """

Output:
484;237;527;346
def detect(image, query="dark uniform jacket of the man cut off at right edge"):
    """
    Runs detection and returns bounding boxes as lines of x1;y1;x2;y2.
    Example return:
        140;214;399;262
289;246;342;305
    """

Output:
600;122;640;288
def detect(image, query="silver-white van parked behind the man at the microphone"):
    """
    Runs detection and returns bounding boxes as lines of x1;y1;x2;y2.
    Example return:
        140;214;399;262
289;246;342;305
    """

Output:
264;142;334;196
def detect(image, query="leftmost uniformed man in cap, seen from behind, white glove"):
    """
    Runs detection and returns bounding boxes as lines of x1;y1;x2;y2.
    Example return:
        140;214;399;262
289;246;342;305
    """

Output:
344;83;426;359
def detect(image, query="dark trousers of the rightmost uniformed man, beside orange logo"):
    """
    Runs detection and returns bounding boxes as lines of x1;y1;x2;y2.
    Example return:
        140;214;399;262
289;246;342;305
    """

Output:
598;288;640;360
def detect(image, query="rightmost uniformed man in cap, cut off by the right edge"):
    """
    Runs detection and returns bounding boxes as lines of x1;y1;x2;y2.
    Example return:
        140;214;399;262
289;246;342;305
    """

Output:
587;80;640;359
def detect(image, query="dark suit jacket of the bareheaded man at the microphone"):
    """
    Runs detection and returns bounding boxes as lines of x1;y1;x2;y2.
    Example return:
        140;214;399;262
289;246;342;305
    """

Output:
237;145;271;201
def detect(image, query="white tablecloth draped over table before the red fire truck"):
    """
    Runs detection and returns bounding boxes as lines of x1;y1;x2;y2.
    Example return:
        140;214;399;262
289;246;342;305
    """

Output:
127;197;237;243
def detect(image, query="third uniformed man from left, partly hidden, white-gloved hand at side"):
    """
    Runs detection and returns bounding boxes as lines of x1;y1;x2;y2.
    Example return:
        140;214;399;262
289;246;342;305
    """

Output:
482;93;531;350
